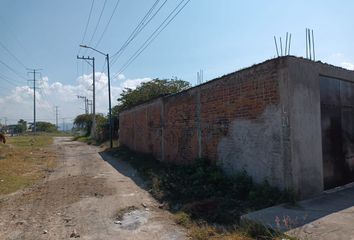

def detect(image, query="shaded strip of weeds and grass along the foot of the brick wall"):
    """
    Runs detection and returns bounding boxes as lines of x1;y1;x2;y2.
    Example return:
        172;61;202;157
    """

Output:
110;147;294;239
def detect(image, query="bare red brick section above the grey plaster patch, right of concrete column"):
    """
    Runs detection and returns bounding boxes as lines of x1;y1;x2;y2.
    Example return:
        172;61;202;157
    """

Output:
201;61;279;160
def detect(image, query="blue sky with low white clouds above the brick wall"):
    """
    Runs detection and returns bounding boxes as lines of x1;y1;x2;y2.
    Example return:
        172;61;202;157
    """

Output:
0;0;354;124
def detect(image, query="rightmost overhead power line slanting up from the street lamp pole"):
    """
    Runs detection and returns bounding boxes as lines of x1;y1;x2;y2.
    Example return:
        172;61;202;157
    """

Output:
114;0;190;77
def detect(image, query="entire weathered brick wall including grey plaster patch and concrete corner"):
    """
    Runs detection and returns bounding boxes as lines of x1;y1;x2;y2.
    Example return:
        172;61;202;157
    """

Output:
120;56;354;198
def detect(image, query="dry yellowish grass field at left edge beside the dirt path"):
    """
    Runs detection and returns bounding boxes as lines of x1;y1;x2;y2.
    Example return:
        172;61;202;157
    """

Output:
0;135;56;195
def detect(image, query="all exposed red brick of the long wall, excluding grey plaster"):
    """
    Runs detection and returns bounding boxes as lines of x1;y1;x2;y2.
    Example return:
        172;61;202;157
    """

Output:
119;59;281;163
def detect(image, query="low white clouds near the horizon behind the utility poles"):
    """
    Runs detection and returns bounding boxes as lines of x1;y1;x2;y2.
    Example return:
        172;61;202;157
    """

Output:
0;72;151;123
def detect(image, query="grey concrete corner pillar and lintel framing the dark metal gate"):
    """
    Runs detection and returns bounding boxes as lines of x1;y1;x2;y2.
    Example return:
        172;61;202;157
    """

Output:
280;57;354;198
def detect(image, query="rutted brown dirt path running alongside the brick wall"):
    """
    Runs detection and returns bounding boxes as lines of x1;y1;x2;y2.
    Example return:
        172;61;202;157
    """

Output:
0;137;186;240
